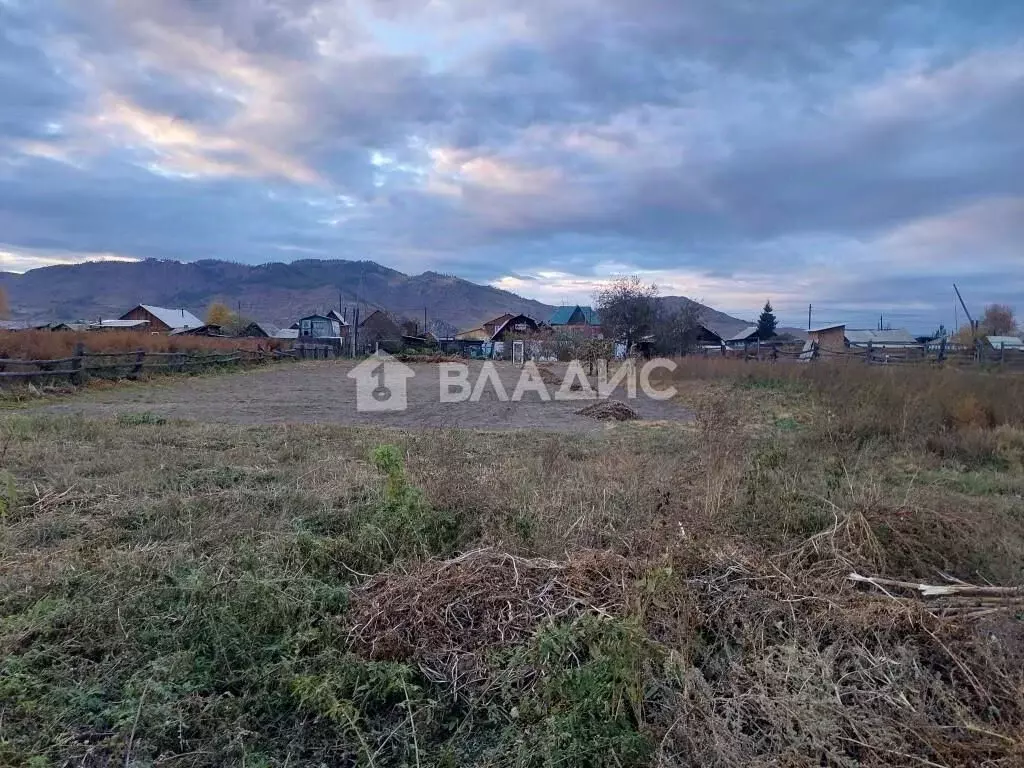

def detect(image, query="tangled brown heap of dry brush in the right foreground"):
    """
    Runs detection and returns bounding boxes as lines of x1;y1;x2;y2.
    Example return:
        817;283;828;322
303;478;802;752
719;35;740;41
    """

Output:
347;536;1024;768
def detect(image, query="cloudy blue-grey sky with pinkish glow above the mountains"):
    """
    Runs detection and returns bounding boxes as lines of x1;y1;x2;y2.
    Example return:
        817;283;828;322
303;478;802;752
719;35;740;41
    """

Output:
0;0;1024;332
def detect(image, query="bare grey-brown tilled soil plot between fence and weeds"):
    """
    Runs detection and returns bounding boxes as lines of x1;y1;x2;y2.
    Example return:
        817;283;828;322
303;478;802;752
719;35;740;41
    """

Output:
43;360;691;432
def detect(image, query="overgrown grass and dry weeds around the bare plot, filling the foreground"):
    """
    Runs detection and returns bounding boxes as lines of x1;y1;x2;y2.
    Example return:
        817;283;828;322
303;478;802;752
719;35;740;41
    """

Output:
0;361;1024;768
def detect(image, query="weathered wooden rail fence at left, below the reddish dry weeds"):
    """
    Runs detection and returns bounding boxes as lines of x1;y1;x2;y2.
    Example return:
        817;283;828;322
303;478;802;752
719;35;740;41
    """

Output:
0;344;296;385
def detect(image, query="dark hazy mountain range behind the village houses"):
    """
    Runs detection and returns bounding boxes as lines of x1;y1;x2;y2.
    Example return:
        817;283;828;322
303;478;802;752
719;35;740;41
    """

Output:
0;259;751;334
